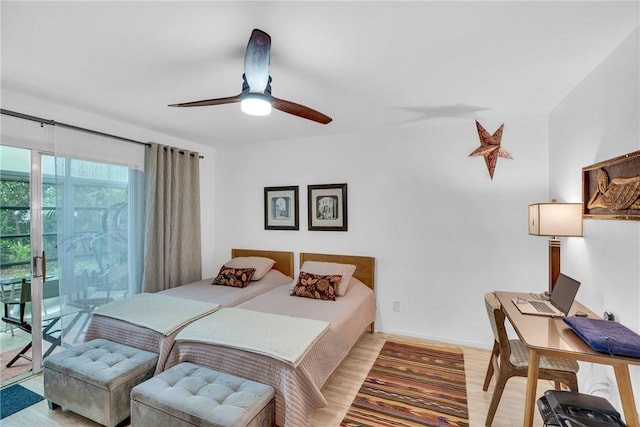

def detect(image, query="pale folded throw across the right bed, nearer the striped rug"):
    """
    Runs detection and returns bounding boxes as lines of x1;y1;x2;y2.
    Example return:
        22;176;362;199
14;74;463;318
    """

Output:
176;307;330;368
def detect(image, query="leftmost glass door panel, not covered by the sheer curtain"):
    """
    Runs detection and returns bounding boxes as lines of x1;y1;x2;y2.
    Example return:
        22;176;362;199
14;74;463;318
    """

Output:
0;146;51;381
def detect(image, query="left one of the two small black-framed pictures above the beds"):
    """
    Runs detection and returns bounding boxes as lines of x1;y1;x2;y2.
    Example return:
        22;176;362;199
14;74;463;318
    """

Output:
264;185;300;230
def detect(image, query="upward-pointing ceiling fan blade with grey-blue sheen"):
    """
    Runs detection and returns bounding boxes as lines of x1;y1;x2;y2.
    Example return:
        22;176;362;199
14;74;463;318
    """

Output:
244;28;271;93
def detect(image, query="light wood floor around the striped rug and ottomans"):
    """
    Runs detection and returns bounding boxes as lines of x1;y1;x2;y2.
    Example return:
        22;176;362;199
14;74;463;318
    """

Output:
2;333;552;427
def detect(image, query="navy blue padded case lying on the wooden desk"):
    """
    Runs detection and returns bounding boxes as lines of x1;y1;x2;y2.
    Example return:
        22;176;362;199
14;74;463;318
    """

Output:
562;317;640;358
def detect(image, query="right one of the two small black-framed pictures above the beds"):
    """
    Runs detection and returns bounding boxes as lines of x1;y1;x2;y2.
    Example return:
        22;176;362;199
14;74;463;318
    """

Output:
307;184;347;231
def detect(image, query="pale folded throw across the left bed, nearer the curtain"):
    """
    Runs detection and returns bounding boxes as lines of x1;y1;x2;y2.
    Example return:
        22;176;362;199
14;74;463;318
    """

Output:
93;293;220;336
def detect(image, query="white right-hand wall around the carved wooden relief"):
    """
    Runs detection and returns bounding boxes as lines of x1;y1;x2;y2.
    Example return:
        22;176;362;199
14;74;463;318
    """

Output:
549;30;640;412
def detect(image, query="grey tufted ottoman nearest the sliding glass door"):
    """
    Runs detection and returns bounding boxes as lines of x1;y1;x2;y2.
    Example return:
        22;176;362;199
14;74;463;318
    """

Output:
43;338;158;427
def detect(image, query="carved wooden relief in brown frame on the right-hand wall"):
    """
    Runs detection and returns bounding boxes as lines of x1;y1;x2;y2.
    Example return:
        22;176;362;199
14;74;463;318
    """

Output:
582;151;640;221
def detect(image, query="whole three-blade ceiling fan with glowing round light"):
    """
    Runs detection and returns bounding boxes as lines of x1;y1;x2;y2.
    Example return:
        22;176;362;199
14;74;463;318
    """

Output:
169;28;332;125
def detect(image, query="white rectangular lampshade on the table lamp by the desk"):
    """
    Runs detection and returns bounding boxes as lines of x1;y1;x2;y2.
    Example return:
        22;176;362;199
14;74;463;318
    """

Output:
529;202;582;237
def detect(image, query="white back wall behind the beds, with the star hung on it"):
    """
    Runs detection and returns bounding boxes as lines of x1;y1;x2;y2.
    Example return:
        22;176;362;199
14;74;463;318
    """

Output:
212;112;548;347
